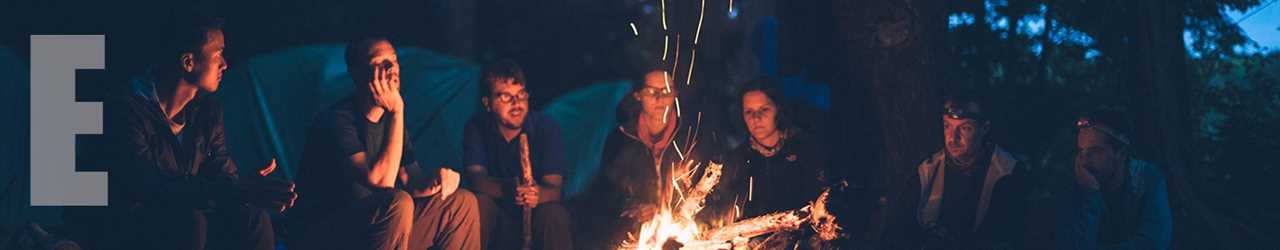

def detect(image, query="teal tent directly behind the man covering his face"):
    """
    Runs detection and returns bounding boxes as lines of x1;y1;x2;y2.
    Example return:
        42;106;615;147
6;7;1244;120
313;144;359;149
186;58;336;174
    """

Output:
218;44;479;177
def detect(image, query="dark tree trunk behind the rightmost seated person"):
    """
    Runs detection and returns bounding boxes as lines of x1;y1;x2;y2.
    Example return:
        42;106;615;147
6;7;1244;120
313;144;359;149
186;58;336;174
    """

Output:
1120;0;1239;249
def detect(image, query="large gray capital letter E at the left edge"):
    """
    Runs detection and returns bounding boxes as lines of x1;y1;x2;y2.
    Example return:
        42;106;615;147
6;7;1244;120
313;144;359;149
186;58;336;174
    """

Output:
31;35;106;206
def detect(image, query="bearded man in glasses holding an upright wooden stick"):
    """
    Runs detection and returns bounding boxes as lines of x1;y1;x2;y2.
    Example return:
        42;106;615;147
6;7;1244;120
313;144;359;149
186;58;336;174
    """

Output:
462;59;573;249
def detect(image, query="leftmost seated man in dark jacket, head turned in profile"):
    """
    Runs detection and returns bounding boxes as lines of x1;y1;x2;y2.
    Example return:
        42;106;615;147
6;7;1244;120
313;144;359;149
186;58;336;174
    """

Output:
99;18;297;250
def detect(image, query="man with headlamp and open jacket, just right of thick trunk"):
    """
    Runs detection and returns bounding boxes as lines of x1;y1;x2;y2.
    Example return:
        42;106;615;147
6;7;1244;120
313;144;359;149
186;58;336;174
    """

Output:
899;95;1030;249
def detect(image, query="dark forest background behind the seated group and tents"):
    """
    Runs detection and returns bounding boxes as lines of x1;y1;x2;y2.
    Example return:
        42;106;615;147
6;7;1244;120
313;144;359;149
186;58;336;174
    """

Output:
0;0;1280;249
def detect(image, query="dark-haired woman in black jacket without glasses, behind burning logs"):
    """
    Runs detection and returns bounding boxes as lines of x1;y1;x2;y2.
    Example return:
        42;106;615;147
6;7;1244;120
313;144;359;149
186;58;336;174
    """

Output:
700;78;828;245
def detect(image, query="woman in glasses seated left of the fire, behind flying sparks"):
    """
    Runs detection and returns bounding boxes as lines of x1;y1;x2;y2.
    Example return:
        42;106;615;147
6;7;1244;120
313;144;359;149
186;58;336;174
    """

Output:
572;67;713;249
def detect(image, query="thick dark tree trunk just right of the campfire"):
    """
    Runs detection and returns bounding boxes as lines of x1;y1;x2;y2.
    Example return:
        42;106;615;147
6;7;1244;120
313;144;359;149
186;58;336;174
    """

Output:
832;0;946;241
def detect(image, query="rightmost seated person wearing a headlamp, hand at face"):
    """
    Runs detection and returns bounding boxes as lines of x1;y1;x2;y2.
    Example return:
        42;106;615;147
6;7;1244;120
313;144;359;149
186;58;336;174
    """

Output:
1071;112;1172;249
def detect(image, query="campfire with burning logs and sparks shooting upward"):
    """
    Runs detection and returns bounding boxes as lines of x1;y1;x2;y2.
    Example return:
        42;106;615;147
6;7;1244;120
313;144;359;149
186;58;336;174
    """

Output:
618;0;841;250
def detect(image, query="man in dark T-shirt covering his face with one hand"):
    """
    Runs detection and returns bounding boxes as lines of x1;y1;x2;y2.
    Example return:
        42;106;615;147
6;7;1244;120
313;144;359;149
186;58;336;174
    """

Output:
289;38;480;250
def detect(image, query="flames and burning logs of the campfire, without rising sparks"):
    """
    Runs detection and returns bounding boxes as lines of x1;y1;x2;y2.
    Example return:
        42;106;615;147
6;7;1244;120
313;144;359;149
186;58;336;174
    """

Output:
618;160;841;250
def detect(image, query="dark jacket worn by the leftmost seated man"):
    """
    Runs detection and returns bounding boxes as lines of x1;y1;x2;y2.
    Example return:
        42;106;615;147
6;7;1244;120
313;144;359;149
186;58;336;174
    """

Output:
104;81;243;209
